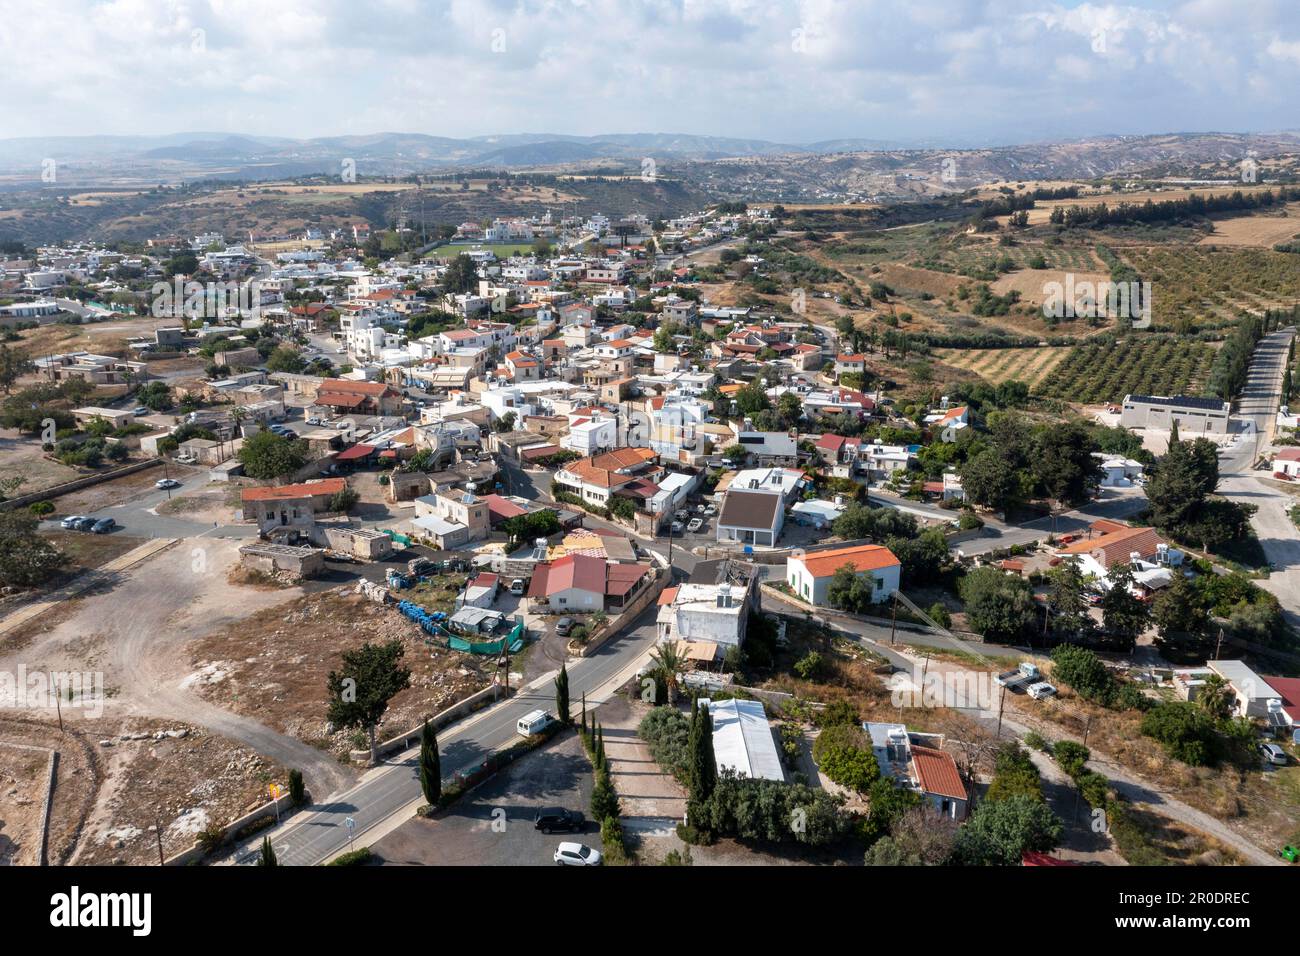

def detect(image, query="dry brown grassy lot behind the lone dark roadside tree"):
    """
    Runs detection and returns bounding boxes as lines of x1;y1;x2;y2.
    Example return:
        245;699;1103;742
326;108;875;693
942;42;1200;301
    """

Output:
182;588;495;756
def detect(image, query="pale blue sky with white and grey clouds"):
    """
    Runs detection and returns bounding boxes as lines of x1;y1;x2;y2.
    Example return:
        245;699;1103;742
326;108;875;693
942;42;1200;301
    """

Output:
0;0;1300;146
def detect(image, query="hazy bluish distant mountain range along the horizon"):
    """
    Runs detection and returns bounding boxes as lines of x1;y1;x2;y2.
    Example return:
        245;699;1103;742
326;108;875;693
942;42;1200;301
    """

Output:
0;131;1300;195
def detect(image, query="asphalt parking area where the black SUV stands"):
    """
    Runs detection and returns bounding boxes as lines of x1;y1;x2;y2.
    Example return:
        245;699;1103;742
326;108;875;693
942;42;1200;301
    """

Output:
371;731;602;866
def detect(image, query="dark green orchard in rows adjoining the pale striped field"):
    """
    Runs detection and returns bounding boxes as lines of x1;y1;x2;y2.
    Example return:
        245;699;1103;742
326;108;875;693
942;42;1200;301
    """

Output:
1035;336;1214;405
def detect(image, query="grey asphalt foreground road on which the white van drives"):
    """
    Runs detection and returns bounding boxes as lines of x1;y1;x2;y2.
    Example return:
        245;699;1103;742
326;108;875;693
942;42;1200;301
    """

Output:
223;607;657;866
